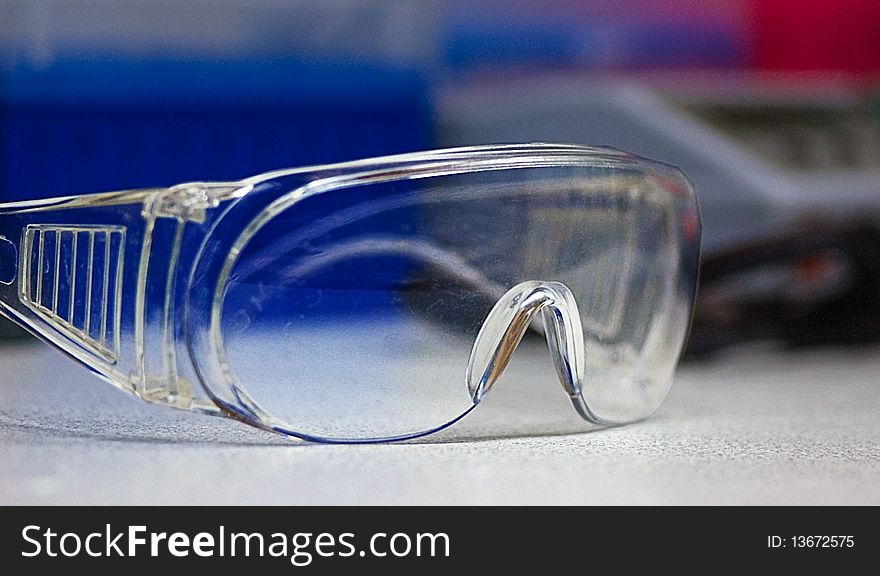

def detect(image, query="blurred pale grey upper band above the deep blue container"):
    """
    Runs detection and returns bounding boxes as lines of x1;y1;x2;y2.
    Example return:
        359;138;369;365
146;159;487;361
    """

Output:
0;0;438;66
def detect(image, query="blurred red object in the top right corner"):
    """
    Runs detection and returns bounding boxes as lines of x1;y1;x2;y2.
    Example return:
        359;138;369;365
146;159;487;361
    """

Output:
752;0;880;72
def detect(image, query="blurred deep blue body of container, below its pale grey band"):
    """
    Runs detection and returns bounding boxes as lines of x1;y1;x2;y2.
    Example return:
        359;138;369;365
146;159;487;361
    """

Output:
0;59;432;201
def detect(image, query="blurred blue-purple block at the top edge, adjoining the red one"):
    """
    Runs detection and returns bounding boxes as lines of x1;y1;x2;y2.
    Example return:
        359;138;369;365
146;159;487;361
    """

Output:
443;0;749;71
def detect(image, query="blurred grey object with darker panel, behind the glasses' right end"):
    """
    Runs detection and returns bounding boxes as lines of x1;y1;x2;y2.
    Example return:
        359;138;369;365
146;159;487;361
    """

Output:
439;73;880;253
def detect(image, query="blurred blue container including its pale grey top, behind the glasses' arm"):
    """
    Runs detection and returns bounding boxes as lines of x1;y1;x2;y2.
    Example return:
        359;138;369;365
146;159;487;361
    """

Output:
0;0;436;338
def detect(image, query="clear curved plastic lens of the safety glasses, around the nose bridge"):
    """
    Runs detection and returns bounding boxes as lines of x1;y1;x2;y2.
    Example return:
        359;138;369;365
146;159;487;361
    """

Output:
220;167;696;440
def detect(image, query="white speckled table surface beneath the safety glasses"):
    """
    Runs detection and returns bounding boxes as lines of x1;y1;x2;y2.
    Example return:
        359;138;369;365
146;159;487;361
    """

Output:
0;342;880;505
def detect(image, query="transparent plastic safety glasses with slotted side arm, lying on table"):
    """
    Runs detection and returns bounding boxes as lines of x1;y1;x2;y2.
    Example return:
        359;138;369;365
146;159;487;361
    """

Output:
0;144;700;442
